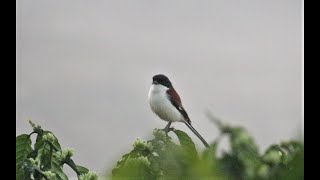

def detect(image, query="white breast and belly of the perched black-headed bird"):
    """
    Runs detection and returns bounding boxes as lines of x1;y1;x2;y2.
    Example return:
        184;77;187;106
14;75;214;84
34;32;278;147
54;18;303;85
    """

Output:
148;84;183;122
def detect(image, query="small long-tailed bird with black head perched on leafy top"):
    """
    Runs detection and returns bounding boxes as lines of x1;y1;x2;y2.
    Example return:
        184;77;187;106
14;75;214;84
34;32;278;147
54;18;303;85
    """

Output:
148;74;209;148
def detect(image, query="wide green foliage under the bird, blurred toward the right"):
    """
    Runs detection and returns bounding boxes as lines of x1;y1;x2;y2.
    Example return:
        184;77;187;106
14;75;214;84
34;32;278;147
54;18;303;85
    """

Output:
111;117;304;180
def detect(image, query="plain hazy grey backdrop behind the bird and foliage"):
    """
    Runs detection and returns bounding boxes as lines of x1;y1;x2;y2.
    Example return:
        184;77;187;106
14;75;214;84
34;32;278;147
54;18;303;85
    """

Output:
16;0;302;176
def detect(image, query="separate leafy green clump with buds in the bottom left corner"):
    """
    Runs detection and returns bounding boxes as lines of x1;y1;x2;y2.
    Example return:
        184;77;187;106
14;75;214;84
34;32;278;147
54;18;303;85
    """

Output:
16;121;97;180
